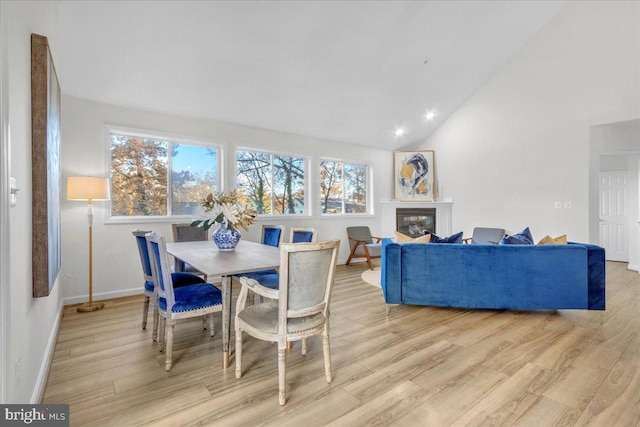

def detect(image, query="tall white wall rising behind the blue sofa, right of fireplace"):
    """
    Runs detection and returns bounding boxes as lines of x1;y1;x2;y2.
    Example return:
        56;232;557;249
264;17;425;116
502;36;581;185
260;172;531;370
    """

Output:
422;1;640;242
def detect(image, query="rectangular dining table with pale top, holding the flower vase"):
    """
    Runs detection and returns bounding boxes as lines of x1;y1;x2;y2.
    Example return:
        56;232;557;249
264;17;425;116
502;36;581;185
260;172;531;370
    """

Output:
167;240;280;369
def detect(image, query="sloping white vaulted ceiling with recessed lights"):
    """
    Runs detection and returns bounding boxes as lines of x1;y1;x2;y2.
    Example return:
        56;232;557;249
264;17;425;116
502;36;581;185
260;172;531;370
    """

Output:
56;1;565;149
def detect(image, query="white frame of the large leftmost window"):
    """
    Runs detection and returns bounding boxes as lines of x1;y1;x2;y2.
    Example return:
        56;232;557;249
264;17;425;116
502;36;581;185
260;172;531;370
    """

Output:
103;125;226;224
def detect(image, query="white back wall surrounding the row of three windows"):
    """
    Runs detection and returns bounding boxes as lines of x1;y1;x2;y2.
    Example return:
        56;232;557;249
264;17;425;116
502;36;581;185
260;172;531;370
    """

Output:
60;96;392;303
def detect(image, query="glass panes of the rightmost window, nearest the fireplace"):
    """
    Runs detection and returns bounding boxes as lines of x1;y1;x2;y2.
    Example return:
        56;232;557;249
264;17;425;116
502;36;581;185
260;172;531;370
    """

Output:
320;160;369;214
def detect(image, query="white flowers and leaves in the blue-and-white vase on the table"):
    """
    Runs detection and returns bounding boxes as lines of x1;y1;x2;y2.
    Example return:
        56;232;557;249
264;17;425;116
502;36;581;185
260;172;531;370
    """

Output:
191;190;258;231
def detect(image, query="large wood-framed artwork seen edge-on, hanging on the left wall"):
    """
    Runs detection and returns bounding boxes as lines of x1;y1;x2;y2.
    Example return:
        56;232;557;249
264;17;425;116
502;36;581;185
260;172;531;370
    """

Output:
31;34;60;297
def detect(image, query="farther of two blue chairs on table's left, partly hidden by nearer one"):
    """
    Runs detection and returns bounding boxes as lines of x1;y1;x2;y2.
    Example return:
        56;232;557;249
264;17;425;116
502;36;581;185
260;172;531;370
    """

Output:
131;228;204;341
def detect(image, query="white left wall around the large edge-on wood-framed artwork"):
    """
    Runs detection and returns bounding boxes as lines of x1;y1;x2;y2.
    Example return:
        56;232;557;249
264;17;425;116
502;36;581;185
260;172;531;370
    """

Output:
2;2;62;403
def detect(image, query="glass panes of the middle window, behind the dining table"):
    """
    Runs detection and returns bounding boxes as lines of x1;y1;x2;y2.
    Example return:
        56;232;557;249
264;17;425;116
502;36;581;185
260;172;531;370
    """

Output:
236;150;305;215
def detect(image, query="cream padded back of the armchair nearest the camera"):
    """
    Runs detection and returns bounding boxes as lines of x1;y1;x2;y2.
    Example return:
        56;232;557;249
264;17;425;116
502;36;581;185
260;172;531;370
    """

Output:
278;240;340;320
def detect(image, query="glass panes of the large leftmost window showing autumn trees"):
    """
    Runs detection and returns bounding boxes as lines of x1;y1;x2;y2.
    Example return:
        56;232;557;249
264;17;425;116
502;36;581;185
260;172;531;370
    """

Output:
109;132;220;217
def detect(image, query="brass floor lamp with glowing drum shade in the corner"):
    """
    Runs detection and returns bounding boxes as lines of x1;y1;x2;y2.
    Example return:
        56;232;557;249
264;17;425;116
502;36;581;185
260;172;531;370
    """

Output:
67;176;109;313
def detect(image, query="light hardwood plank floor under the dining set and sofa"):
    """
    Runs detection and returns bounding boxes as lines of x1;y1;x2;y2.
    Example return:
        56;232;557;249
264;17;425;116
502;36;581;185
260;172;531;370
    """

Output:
43;263;640;427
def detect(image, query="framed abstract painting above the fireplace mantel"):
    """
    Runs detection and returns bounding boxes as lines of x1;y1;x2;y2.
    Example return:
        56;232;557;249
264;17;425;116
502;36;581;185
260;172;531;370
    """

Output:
393;150;436;202
